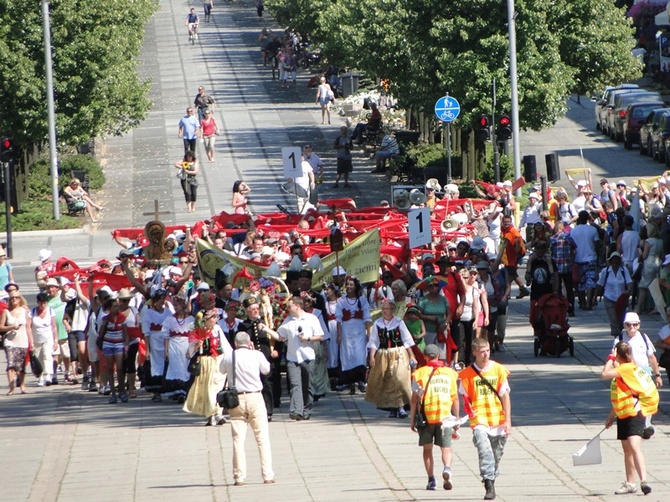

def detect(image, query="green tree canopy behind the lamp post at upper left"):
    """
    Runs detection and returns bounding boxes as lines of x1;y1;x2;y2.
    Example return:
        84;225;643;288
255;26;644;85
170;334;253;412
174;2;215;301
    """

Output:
0;0;156;145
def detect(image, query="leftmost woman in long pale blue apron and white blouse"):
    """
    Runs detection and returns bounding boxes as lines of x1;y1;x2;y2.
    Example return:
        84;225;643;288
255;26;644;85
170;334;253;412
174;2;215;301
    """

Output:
141;288;173;403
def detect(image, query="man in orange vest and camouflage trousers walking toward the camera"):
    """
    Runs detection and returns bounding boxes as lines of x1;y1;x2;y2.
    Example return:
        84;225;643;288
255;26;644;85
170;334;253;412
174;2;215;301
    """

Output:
458;338;512;500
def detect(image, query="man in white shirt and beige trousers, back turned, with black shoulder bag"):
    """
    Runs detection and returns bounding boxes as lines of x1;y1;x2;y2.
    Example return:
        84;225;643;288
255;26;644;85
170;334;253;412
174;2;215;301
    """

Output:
220;331;275;486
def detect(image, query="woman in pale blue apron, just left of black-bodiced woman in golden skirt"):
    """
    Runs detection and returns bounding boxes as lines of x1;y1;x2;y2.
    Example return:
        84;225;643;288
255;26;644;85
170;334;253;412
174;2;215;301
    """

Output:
335;277;372;394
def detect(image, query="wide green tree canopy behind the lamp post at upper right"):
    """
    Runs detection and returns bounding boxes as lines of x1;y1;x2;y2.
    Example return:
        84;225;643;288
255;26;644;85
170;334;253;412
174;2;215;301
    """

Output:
266;0;641;130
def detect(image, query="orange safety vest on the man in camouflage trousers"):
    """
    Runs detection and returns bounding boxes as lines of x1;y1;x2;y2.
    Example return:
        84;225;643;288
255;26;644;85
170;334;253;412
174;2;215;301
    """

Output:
458;362;509;429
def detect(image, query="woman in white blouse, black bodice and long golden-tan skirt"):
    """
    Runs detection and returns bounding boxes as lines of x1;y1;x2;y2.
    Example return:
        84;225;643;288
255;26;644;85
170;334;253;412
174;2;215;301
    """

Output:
365;300;416;418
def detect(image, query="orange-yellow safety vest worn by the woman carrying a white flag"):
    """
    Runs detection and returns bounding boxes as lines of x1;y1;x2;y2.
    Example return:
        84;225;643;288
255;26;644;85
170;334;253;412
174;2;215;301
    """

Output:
610;362;659;418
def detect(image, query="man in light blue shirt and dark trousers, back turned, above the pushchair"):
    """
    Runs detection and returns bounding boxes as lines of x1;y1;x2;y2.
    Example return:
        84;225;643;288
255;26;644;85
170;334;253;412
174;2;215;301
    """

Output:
570;211;600;310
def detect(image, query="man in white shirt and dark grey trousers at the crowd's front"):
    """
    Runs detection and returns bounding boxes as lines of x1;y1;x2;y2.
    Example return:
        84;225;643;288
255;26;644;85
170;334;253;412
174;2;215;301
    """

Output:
277;296;323;420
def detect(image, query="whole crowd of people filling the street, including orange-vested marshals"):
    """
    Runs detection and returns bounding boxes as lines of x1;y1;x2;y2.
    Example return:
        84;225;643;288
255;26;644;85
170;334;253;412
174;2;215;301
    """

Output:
0;2;670;499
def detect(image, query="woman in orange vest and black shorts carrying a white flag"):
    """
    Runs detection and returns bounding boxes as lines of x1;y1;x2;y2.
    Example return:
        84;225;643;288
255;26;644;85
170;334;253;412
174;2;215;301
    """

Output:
600;341;659;495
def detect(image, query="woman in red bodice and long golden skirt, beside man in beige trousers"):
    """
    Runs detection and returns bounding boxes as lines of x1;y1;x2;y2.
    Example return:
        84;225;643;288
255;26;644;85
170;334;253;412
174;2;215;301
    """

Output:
183;309;233;425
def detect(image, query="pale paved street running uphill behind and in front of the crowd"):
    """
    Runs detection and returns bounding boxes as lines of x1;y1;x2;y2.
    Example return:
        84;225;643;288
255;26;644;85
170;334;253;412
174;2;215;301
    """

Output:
0;0;670;502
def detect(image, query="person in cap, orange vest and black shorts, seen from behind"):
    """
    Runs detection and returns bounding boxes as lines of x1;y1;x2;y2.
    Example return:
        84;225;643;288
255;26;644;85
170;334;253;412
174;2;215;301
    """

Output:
410;343;460;490
